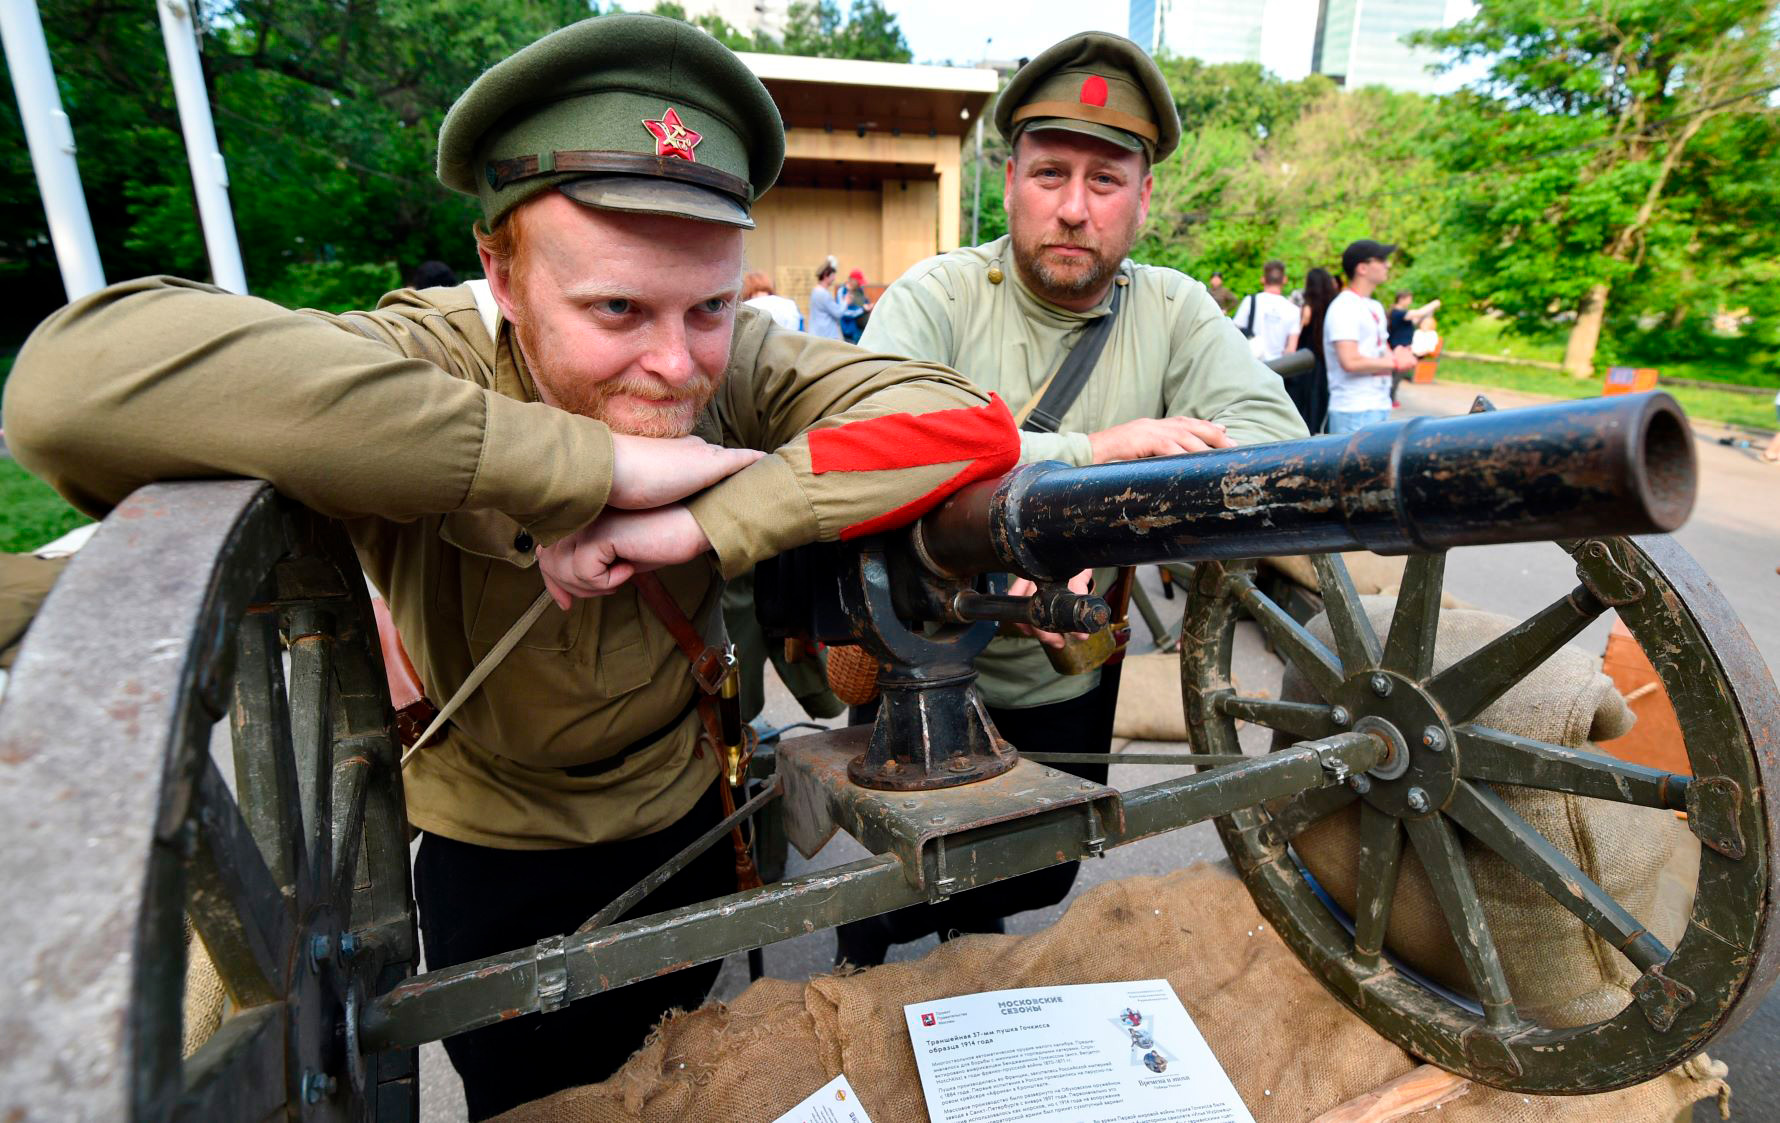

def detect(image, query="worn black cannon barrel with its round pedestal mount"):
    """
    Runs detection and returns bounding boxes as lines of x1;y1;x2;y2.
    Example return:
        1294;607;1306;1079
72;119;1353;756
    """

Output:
796;393;1695;790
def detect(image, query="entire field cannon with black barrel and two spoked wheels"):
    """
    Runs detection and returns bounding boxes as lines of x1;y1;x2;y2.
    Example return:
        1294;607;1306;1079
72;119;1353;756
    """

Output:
0;393;1780;1119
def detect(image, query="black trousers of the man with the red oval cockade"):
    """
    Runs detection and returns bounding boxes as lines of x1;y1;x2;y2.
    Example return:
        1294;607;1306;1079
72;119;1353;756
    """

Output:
835;666;1121;966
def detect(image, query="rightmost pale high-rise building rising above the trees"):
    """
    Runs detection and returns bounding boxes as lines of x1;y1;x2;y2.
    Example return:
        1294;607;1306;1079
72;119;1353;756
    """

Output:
1312;0;1447;93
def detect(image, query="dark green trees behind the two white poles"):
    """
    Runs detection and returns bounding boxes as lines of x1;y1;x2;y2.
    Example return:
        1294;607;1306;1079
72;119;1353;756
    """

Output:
0;0;591;335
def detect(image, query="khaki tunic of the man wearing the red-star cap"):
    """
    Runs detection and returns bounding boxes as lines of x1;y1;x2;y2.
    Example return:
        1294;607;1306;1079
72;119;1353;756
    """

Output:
5;278;988;849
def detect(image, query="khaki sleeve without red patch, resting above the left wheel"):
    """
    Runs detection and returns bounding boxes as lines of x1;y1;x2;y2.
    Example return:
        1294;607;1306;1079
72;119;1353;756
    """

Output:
5;278;611;541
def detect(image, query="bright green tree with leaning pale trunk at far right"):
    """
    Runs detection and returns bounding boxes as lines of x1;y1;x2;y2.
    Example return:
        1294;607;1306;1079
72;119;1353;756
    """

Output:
1420;0;1780;374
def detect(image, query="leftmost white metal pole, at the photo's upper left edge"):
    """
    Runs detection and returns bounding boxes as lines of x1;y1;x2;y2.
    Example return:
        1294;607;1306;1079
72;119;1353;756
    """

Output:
0;0;105;301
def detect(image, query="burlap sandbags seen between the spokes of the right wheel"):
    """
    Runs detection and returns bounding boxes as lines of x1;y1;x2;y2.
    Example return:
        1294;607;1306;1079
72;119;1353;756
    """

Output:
1274;596;1700;1027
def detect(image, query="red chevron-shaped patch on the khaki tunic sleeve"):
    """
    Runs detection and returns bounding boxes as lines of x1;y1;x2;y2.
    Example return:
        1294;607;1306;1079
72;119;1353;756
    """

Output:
810;393;1020;539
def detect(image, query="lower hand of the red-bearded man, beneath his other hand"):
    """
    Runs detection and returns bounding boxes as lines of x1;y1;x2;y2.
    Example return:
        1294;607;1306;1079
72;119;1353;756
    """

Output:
538;504;710;612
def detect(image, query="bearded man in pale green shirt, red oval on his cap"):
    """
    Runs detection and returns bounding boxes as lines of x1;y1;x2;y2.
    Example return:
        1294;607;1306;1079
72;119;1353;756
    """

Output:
838;32;1305;966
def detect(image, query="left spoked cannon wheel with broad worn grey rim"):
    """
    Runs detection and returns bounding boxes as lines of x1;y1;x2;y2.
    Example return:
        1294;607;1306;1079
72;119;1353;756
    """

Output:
0;481;418;1121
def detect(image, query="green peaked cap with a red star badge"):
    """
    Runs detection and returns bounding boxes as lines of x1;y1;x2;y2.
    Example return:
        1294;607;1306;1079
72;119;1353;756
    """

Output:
440;12;785;230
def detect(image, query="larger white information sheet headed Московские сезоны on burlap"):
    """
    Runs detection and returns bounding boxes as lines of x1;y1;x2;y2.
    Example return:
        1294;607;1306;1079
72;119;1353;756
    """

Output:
902;979;1253;1123
